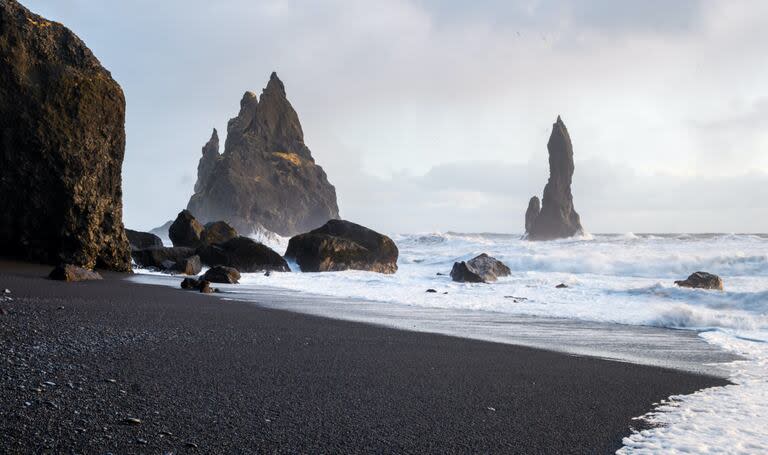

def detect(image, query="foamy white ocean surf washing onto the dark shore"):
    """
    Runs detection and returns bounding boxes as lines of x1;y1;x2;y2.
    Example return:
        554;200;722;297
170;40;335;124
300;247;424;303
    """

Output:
134;232;768;453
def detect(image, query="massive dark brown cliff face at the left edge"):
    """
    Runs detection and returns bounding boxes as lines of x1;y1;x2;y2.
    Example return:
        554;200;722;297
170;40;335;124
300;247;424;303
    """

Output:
0;0;131;271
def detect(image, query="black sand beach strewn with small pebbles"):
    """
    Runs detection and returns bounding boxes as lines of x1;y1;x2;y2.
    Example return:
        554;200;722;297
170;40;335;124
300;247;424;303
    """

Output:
0;261;725;454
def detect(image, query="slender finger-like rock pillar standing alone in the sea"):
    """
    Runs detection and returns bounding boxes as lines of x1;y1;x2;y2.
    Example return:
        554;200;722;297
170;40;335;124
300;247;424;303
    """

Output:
525;116;584;240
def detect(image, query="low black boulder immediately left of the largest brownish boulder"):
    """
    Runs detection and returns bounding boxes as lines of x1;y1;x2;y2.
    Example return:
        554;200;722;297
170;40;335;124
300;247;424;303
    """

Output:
197;237;291;273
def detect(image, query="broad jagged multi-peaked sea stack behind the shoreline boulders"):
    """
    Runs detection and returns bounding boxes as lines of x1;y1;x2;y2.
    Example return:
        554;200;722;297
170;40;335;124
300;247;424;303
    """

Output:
187;73;339;236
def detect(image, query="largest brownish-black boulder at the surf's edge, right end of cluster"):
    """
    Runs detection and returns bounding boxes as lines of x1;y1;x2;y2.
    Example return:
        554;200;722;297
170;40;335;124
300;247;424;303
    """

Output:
285;220;399;273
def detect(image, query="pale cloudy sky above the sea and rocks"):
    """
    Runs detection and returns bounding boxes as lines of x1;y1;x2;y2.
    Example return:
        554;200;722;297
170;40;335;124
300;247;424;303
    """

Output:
22;0;768;233
